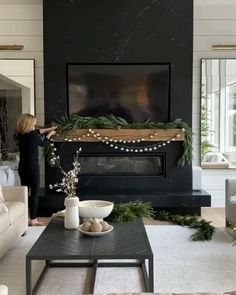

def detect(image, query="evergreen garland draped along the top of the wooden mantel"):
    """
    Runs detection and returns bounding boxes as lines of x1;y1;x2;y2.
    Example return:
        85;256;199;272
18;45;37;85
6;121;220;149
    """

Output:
56;114;192;166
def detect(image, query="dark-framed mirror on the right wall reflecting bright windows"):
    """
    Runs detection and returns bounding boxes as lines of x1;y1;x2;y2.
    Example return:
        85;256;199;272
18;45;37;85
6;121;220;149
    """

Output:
201;58;236;169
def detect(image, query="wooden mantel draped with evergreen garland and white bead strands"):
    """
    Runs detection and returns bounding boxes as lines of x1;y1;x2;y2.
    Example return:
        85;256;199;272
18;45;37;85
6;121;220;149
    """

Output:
45;114;192;166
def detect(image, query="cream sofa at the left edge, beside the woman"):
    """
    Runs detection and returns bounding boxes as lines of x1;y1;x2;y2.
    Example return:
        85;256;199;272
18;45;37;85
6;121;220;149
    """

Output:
0;186;28;257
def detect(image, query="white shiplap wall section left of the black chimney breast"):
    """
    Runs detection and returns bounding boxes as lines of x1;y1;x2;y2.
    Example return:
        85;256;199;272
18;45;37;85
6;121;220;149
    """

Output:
0;0;44;186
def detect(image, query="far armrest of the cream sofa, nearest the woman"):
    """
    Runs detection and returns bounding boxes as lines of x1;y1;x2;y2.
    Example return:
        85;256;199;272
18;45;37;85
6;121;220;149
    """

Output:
2;186;28;204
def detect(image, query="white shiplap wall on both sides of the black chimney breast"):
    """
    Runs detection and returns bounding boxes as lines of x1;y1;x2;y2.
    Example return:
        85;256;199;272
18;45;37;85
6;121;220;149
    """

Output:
0;0;236;206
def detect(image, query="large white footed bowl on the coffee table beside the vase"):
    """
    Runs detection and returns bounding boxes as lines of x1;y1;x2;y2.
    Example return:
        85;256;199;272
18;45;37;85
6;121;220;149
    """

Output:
79;200;114;219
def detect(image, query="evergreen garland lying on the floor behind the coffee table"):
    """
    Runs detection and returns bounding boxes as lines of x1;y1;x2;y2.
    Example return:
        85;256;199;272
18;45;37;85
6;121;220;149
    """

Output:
106;201;215;241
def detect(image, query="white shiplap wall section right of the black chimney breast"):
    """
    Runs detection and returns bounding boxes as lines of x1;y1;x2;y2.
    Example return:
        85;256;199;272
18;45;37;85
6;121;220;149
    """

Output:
193;0;236;207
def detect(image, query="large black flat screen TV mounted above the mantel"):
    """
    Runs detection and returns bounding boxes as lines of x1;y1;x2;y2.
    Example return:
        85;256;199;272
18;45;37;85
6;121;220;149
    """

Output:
67;64;170;122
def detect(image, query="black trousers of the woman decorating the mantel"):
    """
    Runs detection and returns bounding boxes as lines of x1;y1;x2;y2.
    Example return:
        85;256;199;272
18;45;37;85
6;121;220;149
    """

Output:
18;163;40;219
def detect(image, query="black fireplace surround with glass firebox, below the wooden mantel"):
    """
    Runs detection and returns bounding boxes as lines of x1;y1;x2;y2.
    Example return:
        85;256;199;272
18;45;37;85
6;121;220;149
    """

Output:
46;142;188;200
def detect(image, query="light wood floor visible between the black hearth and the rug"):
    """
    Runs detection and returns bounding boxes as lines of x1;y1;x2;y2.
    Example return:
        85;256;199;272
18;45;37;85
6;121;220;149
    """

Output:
39;207;225;227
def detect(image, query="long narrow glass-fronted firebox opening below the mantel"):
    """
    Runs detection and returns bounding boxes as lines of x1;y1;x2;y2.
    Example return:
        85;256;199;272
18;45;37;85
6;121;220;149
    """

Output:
80;154;165;176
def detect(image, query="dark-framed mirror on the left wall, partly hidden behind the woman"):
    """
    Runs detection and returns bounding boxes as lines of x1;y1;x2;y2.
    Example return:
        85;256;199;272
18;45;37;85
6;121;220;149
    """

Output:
0;59;35;165
